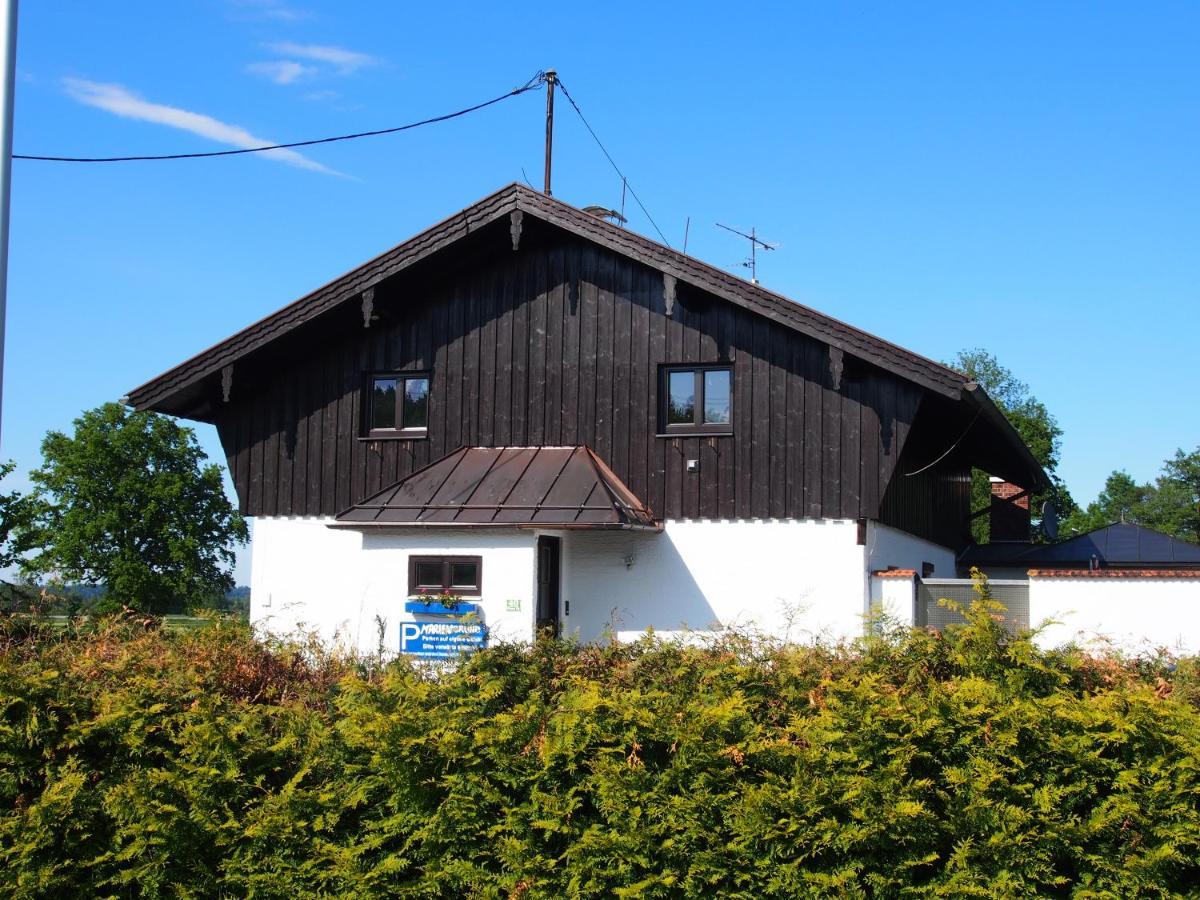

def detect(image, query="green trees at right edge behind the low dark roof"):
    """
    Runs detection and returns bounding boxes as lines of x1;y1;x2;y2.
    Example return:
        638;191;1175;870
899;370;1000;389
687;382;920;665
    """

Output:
1063;446;1200;542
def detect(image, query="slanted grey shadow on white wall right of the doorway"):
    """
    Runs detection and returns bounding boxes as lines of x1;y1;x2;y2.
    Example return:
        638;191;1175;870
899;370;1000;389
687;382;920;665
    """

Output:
564;533;721;641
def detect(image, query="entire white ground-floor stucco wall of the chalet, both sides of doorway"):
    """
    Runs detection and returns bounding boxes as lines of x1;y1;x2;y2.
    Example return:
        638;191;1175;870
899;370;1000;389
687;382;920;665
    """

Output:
251;517;954;653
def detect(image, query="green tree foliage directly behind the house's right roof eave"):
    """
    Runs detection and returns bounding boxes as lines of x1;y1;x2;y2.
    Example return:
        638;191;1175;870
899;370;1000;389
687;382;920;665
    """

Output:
948;348;1075;544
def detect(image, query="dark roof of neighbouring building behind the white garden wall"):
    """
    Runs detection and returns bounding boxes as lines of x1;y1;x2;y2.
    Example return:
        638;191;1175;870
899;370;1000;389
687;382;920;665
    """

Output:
959;522;1200;569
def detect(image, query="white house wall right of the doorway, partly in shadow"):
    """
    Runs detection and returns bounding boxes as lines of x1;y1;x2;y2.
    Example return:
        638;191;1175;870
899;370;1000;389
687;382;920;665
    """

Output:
563;520;868;641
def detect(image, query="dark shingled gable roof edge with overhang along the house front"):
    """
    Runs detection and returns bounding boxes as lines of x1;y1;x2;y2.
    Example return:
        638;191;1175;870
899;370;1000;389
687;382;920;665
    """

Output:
125;184;965;421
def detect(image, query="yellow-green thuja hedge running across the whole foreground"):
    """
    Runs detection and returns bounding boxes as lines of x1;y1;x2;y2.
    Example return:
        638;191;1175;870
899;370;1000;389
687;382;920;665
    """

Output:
0;605;1200;898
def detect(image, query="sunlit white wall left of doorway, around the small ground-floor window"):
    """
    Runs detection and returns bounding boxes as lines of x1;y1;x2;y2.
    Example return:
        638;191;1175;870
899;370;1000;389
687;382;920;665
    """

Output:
250;516;538;653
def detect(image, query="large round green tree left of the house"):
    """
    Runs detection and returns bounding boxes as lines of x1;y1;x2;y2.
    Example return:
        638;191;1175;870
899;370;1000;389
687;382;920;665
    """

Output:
24;403;247;611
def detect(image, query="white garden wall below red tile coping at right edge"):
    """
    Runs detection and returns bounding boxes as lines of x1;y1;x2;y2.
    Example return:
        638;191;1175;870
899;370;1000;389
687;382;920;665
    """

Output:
1030;575;1200;654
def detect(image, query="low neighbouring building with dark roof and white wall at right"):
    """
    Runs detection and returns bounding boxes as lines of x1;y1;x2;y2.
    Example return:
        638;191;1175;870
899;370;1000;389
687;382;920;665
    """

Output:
959;522;1200;653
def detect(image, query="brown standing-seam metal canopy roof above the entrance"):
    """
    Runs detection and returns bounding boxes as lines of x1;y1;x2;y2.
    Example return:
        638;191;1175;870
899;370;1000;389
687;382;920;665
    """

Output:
330;446;662;532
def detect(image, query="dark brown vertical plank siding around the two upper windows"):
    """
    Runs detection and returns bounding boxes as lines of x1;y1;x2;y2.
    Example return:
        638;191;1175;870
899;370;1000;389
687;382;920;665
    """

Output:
215;236;926;521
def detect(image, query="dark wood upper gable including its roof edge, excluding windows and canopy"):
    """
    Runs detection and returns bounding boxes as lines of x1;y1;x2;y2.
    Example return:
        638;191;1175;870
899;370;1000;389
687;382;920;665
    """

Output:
131;188;1044;547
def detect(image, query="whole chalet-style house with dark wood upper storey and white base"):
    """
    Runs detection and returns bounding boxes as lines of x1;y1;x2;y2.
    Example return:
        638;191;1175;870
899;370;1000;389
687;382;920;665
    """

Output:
127;185;1049;655
